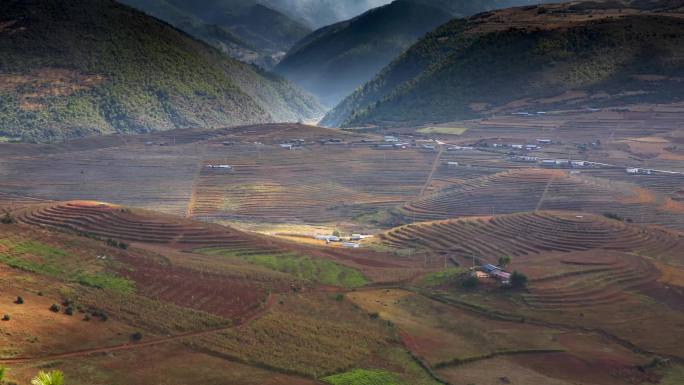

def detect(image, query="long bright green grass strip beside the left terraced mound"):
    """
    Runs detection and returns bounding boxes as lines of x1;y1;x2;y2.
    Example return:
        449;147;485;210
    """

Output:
196;248;369;288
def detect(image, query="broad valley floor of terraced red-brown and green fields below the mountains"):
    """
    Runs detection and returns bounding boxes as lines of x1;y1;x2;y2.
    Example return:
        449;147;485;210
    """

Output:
0;100;684;385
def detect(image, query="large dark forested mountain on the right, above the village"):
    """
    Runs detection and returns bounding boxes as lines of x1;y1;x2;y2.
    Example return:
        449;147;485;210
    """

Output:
322;0;684;126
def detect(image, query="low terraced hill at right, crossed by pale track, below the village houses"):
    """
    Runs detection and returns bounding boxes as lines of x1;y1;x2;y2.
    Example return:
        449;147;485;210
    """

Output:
403;169;684;230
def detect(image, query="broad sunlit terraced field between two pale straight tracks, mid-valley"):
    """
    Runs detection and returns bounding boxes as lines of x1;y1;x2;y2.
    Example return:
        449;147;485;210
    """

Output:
192;145;435;223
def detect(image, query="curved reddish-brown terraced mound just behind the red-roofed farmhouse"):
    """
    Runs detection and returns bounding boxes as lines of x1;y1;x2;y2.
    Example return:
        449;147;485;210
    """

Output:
379;211;684;263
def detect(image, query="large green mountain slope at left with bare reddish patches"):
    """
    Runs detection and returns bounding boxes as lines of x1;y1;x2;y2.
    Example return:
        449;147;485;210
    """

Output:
0;0;321;141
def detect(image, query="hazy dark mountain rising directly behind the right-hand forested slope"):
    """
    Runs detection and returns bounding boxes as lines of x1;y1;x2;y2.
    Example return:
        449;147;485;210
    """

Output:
274;0;451;106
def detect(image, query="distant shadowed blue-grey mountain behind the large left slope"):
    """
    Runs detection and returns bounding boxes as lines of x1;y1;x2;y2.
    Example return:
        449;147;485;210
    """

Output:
121;0;311;68
